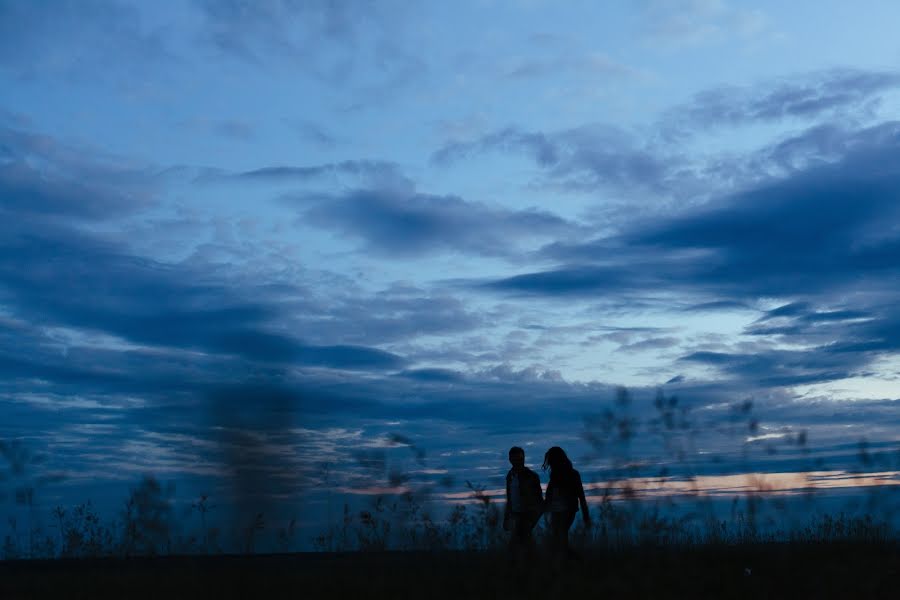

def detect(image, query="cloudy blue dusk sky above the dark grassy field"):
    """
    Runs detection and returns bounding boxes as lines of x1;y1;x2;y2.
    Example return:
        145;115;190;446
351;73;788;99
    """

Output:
0;0;900;544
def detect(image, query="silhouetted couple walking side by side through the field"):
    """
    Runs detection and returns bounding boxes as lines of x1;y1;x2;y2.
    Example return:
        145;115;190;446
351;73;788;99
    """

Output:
503;446;591;566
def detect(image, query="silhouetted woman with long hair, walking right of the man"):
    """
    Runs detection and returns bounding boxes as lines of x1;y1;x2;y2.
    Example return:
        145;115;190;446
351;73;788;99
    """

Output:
543;446;591;564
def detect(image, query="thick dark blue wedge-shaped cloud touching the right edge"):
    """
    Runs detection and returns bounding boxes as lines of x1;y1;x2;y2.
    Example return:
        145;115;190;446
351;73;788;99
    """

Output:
626;123;900;296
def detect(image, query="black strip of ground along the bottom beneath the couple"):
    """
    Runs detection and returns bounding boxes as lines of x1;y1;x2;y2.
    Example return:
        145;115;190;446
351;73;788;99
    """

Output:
0;543;900;600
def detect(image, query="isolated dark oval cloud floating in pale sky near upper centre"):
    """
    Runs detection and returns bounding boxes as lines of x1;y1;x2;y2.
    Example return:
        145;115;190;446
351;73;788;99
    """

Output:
304;189;577;256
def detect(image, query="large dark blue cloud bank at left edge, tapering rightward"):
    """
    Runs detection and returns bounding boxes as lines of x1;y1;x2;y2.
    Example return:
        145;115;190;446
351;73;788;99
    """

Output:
0;125;405;370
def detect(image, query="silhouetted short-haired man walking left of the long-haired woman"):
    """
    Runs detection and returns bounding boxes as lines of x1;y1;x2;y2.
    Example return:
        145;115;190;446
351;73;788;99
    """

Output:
503;446;544;560
